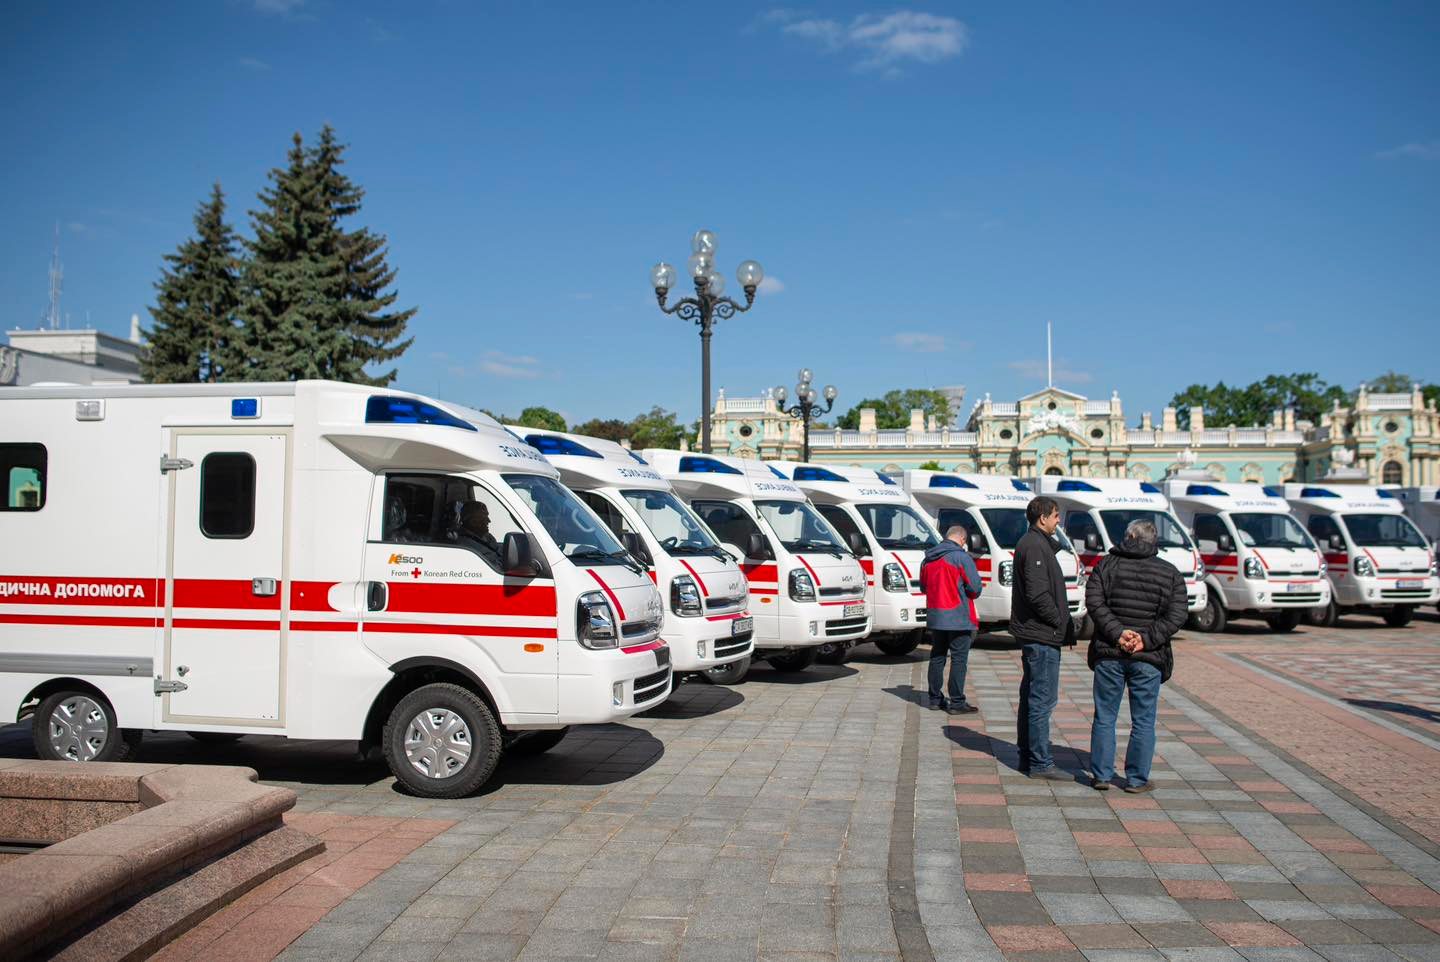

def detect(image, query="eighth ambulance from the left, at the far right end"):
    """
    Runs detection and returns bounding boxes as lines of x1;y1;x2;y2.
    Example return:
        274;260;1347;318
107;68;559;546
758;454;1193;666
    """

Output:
1284;481;1440;628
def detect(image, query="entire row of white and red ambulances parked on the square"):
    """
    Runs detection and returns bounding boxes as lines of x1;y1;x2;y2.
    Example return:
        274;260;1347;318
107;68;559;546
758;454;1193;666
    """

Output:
0;382;1437;798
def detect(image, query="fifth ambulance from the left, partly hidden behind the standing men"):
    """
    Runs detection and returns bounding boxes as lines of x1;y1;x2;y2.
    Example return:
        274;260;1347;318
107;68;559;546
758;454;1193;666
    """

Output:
896;469;1084;631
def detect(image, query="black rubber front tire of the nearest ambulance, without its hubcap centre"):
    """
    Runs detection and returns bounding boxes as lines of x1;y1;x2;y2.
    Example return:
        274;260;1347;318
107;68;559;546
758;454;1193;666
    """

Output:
382;683;500;798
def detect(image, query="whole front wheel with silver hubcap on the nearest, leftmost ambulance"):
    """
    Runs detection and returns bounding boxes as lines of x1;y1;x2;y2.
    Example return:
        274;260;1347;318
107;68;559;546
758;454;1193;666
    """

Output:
383;683;501;798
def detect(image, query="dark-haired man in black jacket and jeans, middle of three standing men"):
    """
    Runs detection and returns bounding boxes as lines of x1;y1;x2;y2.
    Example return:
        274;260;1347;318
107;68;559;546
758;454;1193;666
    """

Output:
1009;497;1076;781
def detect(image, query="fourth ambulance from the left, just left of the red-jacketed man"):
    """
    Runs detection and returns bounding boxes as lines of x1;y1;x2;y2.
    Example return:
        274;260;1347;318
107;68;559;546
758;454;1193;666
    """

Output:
766;461;940;661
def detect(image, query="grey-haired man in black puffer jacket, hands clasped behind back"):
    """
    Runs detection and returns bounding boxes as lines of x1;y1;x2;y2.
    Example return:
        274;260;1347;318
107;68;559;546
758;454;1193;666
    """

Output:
1084;520;1188;794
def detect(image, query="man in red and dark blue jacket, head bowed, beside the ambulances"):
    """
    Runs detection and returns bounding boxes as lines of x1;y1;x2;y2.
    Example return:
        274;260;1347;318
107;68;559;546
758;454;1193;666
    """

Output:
920;524;981;714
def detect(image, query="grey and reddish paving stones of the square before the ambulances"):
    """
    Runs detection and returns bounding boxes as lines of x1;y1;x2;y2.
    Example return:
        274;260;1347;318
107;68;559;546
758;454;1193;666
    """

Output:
0;619;1440;962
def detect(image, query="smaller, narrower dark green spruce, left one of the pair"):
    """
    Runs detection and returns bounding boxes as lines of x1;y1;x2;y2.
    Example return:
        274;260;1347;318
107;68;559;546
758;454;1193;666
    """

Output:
140;183;240;385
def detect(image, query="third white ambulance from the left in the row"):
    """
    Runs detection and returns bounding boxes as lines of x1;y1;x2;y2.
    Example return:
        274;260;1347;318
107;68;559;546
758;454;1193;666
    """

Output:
641;448;871;671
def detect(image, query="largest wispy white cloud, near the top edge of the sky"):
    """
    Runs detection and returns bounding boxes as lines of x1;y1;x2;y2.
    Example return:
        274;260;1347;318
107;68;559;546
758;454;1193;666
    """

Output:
757;9;969;75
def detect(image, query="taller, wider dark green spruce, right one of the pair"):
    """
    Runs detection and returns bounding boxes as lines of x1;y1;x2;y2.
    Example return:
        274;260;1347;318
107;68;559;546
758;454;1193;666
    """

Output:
235;125;415;385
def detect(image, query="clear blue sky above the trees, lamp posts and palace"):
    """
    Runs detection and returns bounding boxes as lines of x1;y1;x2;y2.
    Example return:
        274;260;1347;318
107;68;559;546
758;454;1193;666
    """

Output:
0;0;1440;422
